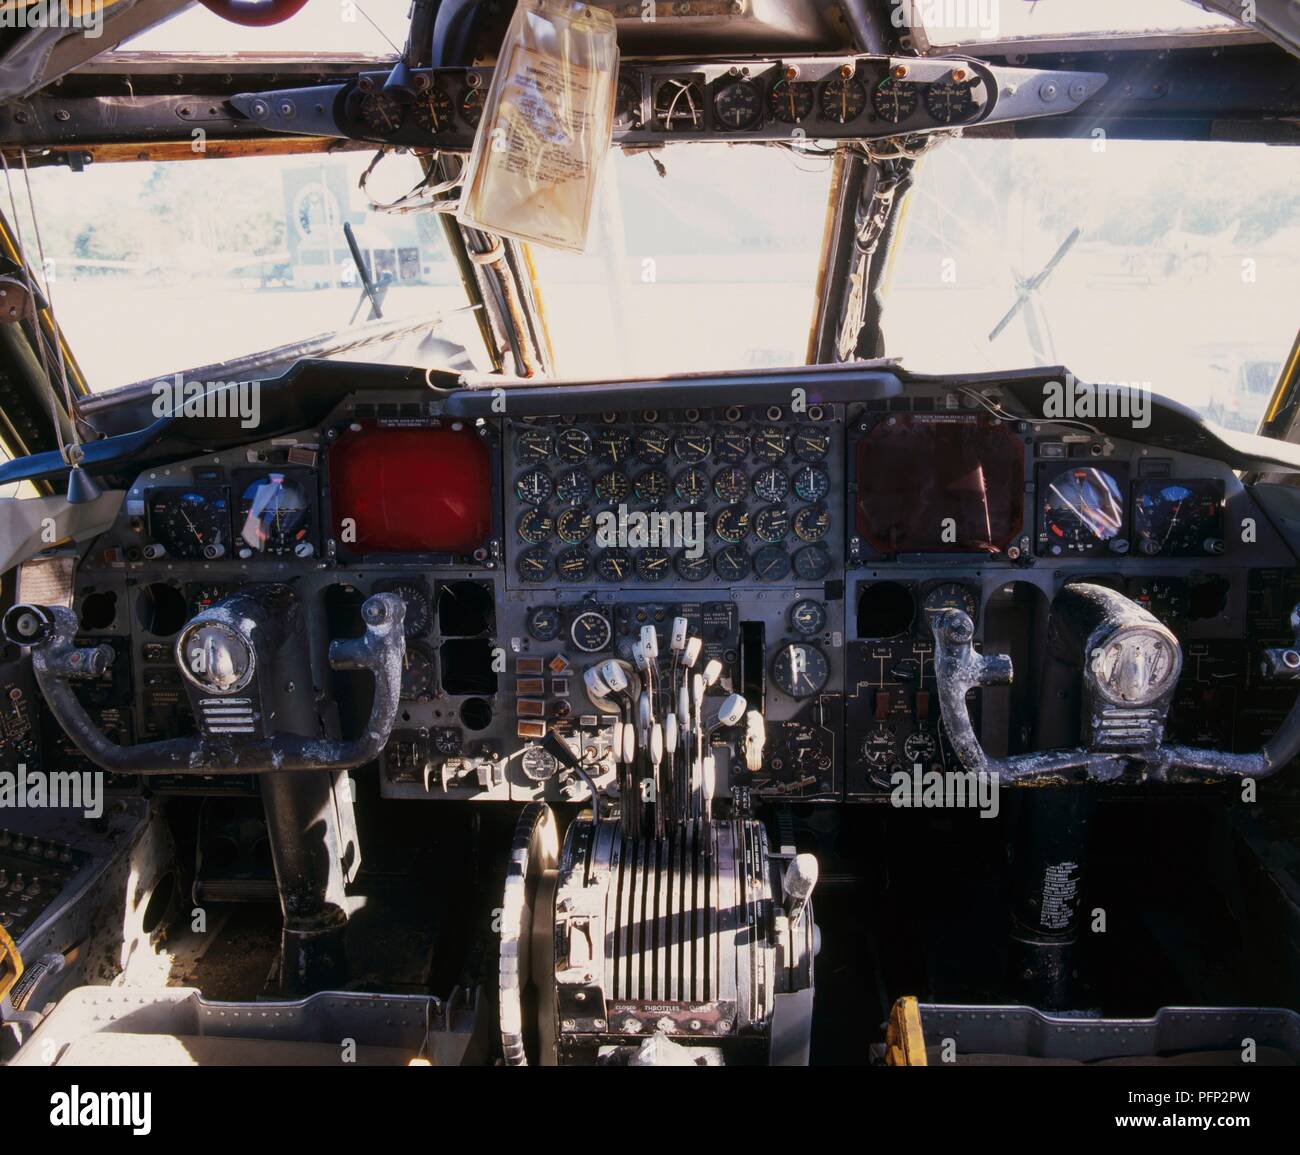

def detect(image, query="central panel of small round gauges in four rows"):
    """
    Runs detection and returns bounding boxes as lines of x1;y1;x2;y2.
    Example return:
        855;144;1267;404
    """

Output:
506;406;842;587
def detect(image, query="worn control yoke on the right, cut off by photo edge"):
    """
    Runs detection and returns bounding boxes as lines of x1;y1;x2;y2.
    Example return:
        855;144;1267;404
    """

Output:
933;584;1300;786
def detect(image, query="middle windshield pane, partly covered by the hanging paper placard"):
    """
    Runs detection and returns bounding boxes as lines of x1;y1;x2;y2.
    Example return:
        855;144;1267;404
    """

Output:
532;144;831;377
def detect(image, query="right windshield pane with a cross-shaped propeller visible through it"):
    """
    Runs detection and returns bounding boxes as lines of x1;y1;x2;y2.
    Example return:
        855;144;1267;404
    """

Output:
883;137;1300;429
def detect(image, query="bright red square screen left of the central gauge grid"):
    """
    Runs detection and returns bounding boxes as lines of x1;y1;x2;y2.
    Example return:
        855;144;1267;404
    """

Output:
329;425;491;555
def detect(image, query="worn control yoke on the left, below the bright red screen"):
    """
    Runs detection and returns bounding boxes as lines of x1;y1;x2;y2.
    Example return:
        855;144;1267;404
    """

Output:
0;593;406;775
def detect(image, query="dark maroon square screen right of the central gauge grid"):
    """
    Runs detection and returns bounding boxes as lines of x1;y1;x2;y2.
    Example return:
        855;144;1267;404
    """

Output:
857;414;1024;554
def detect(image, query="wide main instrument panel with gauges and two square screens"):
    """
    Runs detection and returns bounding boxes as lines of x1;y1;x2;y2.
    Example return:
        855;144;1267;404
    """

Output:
25;384;1300;801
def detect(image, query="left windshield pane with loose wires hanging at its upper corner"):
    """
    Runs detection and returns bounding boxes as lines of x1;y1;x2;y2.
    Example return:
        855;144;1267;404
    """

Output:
13;152;489;392
